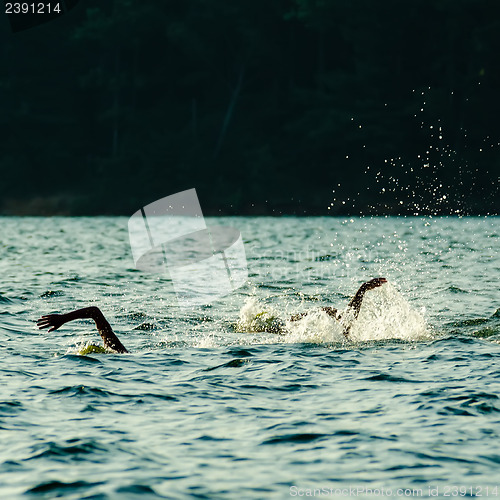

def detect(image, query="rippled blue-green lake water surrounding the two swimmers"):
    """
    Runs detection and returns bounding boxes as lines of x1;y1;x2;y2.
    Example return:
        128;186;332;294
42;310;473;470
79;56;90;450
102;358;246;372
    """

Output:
0;217;500;499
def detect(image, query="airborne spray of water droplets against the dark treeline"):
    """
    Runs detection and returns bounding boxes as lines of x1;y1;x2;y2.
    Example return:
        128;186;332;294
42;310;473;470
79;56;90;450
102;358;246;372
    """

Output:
327;87;500;216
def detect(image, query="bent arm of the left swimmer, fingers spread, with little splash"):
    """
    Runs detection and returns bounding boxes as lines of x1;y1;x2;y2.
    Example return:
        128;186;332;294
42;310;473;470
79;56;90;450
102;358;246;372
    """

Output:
37;306;128;353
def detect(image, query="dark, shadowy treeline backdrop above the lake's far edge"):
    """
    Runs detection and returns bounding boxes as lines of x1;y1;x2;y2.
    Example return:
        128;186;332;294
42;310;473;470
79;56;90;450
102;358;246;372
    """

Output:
0;0;500;215
